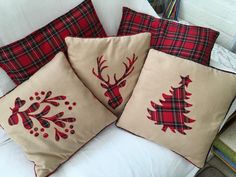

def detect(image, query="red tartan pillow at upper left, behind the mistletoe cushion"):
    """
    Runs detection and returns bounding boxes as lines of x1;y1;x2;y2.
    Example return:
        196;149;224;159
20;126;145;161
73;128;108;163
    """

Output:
0;0;106;84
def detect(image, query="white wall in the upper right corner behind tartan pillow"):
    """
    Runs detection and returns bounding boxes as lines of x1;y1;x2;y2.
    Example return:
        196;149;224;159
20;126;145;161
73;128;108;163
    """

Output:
179;0;236;52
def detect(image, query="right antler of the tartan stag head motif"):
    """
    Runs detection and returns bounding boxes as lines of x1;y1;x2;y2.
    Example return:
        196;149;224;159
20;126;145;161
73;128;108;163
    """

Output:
114;54;138;84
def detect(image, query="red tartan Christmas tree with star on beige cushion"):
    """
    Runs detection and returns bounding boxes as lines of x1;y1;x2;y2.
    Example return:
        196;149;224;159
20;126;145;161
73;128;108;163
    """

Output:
147;75;195;135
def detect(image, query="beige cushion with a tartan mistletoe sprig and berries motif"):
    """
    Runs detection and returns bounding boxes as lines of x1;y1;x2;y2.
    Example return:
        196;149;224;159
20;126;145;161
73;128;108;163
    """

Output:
0;53;116;177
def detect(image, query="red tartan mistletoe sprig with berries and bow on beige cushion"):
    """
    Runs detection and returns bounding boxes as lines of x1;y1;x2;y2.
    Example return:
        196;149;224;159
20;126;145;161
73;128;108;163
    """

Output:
8;91;76;141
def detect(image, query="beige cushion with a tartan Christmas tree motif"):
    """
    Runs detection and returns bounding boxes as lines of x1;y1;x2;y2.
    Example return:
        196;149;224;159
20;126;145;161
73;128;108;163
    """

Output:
117;49;236;167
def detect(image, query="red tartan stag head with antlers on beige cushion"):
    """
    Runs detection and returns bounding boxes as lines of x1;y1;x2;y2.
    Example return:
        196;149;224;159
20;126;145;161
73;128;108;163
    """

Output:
92;54;138;109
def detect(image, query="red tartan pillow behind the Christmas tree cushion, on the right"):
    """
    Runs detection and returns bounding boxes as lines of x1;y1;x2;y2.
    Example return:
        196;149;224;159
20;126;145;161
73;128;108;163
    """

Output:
118;7;219;66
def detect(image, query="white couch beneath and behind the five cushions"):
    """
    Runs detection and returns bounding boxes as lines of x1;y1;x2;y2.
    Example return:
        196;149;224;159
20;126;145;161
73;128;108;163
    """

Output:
0;0;234;177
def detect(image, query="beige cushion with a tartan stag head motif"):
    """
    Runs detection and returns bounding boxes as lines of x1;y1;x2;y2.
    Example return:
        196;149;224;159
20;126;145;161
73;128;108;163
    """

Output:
66;33;150;115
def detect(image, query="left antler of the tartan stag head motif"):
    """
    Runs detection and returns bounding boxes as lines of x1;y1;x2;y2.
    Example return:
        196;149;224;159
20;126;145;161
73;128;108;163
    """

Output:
93;56;110;85
